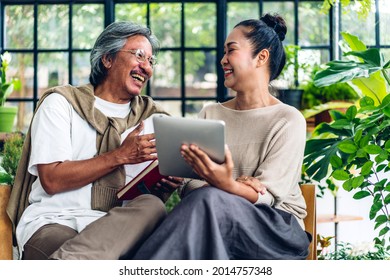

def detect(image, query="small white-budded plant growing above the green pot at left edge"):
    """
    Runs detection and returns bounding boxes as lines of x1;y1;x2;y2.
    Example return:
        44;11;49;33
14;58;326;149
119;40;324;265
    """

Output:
0;52;21;106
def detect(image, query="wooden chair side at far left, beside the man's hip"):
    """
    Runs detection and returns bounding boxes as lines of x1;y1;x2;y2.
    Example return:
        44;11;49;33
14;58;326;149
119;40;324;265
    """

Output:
0;185;13;260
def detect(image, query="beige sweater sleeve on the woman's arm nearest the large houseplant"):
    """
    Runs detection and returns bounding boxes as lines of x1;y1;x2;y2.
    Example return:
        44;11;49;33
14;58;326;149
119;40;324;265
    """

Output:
255;108;306;216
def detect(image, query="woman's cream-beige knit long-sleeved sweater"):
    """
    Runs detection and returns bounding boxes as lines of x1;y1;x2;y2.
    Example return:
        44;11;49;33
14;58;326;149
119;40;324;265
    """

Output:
183;103;306;224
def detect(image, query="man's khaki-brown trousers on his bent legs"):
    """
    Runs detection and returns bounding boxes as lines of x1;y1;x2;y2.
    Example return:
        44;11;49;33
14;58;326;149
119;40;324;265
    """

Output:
23;195;166;260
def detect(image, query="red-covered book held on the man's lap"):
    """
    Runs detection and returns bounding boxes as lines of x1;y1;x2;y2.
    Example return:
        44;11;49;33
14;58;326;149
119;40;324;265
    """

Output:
117;159;168;200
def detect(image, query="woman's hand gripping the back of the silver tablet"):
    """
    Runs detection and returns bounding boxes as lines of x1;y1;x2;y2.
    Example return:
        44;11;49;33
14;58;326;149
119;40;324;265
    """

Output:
181;144;238;193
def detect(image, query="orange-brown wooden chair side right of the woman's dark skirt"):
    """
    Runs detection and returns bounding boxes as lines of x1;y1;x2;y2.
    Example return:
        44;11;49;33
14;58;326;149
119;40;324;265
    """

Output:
301;184;317;260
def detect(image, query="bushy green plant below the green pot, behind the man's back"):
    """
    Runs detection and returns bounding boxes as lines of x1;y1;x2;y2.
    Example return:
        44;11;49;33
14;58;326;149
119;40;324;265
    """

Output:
0;133;24;186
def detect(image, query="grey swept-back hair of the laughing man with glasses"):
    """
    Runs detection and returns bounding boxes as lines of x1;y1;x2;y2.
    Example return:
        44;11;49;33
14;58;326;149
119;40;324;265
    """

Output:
89;21;160;86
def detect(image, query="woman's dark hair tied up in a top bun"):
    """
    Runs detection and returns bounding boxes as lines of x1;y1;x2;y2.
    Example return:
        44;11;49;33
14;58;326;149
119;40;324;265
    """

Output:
234;14;287;81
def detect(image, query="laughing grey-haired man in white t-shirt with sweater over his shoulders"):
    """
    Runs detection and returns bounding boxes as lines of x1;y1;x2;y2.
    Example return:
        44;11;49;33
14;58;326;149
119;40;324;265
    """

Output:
8;22;181;259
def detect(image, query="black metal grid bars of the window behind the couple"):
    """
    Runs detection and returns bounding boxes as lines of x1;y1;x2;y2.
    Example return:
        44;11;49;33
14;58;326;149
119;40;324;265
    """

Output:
0;0;390;116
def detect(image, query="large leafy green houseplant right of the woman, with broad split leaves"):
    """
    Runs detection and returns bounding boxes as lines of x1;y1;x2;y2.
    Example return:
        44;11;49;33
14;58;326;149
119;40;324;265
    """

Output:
304;33;390;250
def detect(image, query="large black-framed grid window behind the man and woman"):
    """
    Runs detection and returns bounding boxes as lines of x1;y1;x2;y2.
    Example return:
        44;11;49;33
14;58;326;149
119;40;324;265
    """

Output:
0;0;390;124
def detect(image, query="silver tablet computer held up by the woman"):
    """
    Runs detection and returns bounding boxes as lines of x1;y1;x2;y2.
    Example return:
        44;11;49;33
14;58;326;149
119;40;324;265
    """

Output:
153;115;225;178
